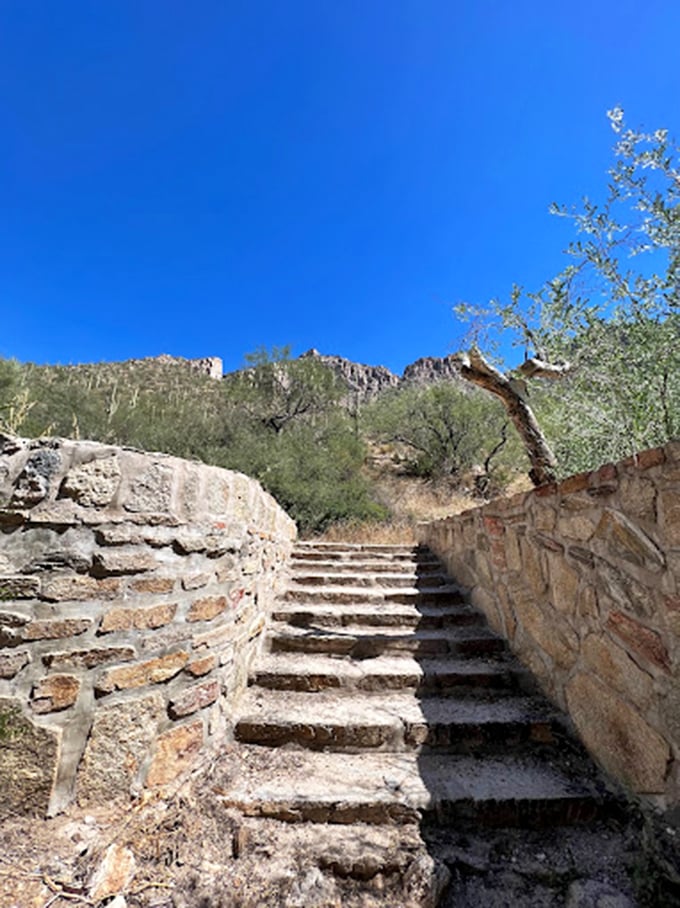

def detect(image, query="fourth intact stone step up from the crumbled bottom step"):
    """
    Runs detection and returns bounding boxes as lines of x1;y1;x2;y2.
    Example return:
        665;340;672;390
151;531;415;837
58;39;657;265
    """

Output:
268;623;506;659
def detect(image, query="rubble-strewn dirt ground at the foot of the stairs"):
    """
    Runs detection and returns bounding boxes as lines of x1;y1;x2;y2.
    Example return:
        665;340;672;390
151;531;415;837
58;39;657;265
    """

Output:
0;748;680;908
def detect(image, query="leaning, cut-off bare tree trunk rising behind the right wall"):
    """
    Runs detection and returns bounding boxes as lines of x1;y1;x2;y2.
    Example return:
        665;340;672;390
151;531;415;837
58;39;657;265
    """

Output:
460;347;556;486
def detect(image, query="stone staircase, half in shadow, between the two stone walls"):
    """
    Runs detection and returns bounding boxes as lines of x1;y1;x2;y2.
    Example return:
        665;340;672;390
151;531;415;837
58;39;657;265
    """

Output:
218;542;636;905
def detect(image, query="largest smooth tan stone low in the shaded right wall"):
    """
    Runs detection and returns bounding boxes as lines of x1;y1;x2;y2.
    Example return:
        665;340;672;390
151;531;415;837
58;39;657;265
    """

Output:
566;673;670;794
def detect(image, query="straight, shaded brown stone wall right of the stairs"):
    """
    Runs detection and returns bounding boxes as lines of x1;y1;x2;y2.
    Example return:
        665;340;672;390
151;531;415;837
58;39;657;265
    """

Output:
421;442;680;805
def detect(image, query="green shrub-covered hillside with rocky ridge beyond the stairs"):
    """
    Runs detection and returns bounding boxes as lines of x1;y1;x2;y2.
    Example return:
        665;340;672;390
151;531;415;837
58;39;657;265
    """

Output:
0;350;522;534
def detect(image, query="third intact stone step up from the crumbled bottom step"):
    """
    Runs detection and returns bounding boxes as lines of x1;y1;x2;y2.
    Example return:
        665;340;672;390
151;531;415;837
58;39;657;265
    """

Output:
250;653;532;696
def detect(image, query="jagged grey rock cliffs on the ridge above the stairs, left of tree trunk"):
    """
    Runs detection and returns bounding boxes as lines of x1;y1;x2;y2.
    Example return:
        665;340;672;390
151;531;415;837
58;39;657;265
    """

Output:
300;348;461;401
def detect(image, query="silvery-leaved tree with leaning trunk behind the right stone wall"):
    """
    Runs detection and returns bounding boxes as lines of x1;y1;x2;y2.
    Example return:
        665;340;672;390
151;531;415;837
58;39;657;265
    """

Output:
457;108;680;485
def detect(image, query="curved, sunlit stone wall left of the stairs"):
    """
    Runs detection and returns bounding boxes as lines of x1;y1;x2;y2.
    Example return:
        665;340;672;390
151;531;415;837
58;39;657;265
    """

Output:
0;436;296;814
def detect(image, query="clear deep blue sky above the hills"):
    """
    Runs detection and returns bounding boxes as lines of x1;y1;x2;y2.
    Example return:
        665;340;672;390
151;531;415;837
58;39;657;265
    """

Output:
0;0;680;371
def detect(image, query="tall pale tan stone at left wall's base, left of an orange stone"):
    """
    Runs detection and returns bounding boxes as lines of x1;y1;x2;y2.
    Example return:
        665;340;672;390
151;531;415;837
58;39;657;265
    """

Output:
77;693;165;804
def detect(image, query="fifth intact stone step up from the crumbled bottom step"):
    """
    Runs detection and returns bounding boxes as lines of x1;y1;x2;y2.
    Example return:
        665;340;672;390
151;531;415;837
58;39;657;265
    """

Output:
272;603;486;630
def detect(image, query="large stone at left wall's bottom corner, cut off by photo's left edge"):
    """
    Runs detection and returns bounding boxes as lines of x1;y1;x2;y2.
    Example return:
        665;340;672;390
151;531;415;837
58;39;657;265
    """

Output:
0;698;62;817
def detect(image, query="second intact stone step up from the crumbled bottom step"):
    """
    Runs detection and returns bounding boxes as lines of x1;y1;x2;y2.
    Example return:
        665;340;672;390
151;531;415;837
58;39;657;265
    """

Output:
234;688;556;753
